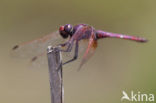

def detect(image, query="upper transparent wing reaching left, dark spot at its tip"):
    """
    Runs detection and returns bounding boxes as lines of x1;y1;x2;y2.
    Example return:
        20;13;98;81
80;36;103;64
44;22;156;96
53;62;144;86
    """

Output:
11;31;64;58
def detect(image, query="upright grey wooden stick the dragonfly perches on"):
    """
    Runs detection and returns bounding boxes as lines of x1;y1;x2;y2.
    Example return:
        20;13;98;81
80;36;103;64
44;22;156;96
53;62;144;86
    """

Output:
47;46;64;103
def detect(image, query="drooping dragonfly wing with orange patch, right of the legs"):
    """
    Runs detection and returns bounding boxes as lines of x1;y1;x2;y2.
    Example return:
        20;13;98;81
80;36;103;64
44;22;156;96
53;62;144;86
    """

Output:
78;32;97;70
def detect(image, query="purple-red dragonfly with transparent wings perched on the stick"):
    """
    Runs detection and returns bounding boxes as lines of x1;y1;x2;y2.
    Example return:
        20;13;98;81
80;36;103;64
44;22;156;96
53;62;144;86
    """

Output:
12;24;147;68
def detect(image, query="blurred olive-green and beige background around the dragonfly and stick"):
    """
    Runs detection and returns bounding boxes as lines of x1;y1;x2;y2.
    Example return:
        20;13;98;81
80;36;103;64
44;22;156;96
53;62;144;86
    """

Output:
0;0;156;103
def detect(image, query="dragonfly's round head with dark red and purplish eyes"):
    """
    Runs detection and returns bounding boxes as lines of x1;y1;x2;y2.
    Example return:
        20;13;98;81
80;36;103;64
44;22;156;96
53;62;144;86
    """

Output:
59;24;73;39
